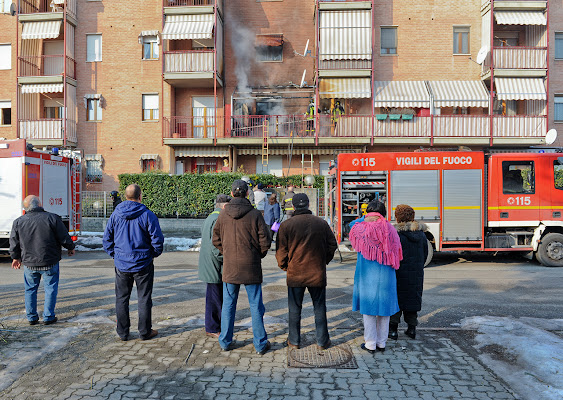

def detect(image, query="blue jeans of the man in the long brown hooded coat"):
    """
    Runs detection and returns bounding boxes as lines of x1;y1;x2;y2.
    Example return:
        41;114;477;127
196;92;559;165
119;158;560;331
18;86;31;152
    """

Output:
219;282;268;352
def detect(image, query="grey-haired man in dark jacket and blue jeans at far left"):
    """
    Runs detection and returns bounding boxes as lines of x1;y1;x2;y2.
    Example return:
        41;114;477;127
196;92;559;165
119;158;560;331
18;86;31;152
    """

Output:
10;196;74;325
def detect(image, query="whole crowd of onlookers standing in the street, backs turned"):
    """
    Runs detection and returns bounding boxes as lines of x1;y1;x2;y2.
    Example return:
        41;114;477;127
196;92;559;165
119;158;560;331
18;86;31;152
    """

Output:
10;180;428;355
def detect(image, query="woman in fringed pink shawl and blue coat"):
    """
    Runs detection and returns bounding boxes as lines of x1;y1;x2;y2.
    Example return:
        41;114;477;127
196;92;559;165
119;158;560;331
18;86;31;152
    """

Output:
350;200;403;354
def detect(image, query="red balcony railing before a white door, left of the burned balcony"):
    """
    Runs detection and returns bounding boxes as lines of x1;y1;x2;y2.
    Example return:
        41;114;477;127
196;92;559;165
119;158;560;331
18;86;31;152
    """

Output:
163;116;223;139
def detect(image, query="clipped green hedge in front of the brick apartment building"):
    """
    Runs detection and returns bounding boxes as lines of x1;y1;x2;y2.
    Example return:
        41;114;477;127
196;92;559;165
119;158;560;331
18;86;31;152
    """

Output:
118;172;324;218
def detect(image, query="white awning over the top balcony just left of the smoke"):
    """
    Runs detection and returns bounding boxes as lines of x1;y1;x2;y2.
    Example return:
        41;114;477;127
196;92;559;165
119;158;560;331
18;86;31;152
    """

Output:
162;14;214;40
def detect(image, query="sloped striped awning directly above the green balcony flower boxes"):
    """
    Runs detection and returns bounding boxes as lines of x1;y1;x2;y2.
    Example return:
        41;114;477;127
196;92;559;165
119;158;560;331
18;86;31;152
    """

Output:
373;81;430;108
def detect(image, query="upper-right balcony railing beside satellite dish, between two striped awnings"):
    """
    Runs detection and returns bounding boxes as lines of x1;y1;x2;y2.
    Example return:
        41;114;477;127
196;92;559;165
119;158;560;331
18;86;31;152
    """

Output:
489;47;547;69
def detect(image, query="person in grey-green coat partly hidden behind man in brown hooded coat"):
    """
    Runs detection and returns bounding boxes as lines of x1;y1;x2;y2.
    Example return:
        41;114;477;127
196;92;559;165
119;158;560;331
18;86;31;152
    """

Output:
198;194;231;338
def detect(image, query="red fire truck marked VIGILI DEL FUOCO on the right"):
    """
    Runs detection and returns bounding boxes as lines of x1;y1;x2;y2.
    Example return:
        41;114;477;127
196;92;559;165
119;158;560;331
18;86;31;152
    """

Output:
334;150;563;267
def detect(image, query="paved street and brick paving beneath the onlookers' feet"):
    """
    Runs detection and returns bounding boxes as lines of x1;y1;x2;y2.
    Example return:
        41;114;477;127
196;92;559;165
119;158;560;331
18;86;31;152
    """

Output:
0;252;563;399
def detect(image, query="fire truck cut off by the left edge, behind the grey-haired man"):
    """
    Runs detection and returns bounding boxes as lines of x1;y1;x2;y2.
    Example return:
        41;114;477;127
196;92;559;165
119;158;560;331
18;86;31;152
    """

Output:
0;139;81;251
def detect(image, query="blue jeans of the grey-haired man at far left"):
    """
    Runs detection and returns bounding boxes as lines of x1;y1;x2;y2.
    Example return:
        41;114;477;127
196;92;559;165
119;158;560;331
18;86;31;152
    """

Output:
23;263;59;321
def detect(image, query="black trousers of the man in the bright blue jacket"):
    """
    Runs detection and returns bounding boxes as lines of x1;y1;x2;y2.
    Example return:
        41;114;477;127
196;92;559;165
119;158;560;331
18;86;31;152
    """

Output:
115;262;154;339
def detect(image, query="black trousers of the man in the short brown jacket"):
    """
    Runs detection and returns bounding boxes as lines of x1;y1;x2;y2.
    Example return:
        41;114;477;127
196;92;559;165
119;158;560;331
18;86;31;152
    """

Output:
287;287;330;346
